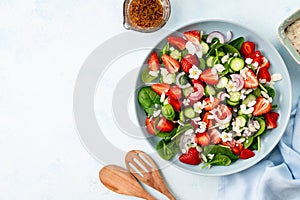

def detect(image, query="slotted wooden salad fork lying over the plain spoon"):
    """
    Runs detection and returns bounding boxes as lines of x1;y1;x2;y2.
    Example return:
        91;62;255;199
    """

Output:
125;150;176;200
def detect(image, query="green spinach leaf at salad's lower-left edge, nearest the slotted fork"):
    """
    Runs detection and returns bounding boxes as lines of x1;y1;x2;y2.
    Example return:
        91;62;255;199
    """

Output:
156;139;179;160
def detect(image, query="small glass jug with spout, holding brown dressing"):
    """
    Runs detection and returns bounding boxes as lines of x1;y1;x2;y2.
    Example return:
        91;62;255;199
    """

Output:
123;0;171;33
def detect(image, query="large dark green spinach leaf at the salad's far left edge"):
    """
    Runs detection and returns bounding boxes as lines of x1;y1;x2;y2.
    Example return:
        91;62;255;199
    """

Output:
138;86;160;114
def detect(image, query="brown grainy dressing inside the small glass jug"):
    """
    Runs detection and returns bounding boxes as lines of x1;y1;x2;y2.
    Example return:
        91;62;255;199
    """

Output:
129;0;163;28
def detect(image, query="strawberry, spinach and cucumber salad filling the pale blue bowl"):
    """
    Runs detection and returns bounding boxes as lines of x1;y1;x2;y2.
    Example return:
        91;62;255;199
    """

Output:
137;21;283;173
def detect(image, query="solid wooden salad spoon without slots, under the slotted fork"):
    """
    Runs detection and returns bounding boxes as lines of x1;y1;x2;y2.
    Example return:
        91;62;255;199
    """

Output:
99;165;155;200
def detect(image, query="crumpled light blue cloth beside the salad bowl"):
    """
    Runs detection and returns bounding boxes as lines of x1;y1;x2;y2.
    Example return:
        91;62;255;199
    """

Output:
218;99;300;200
